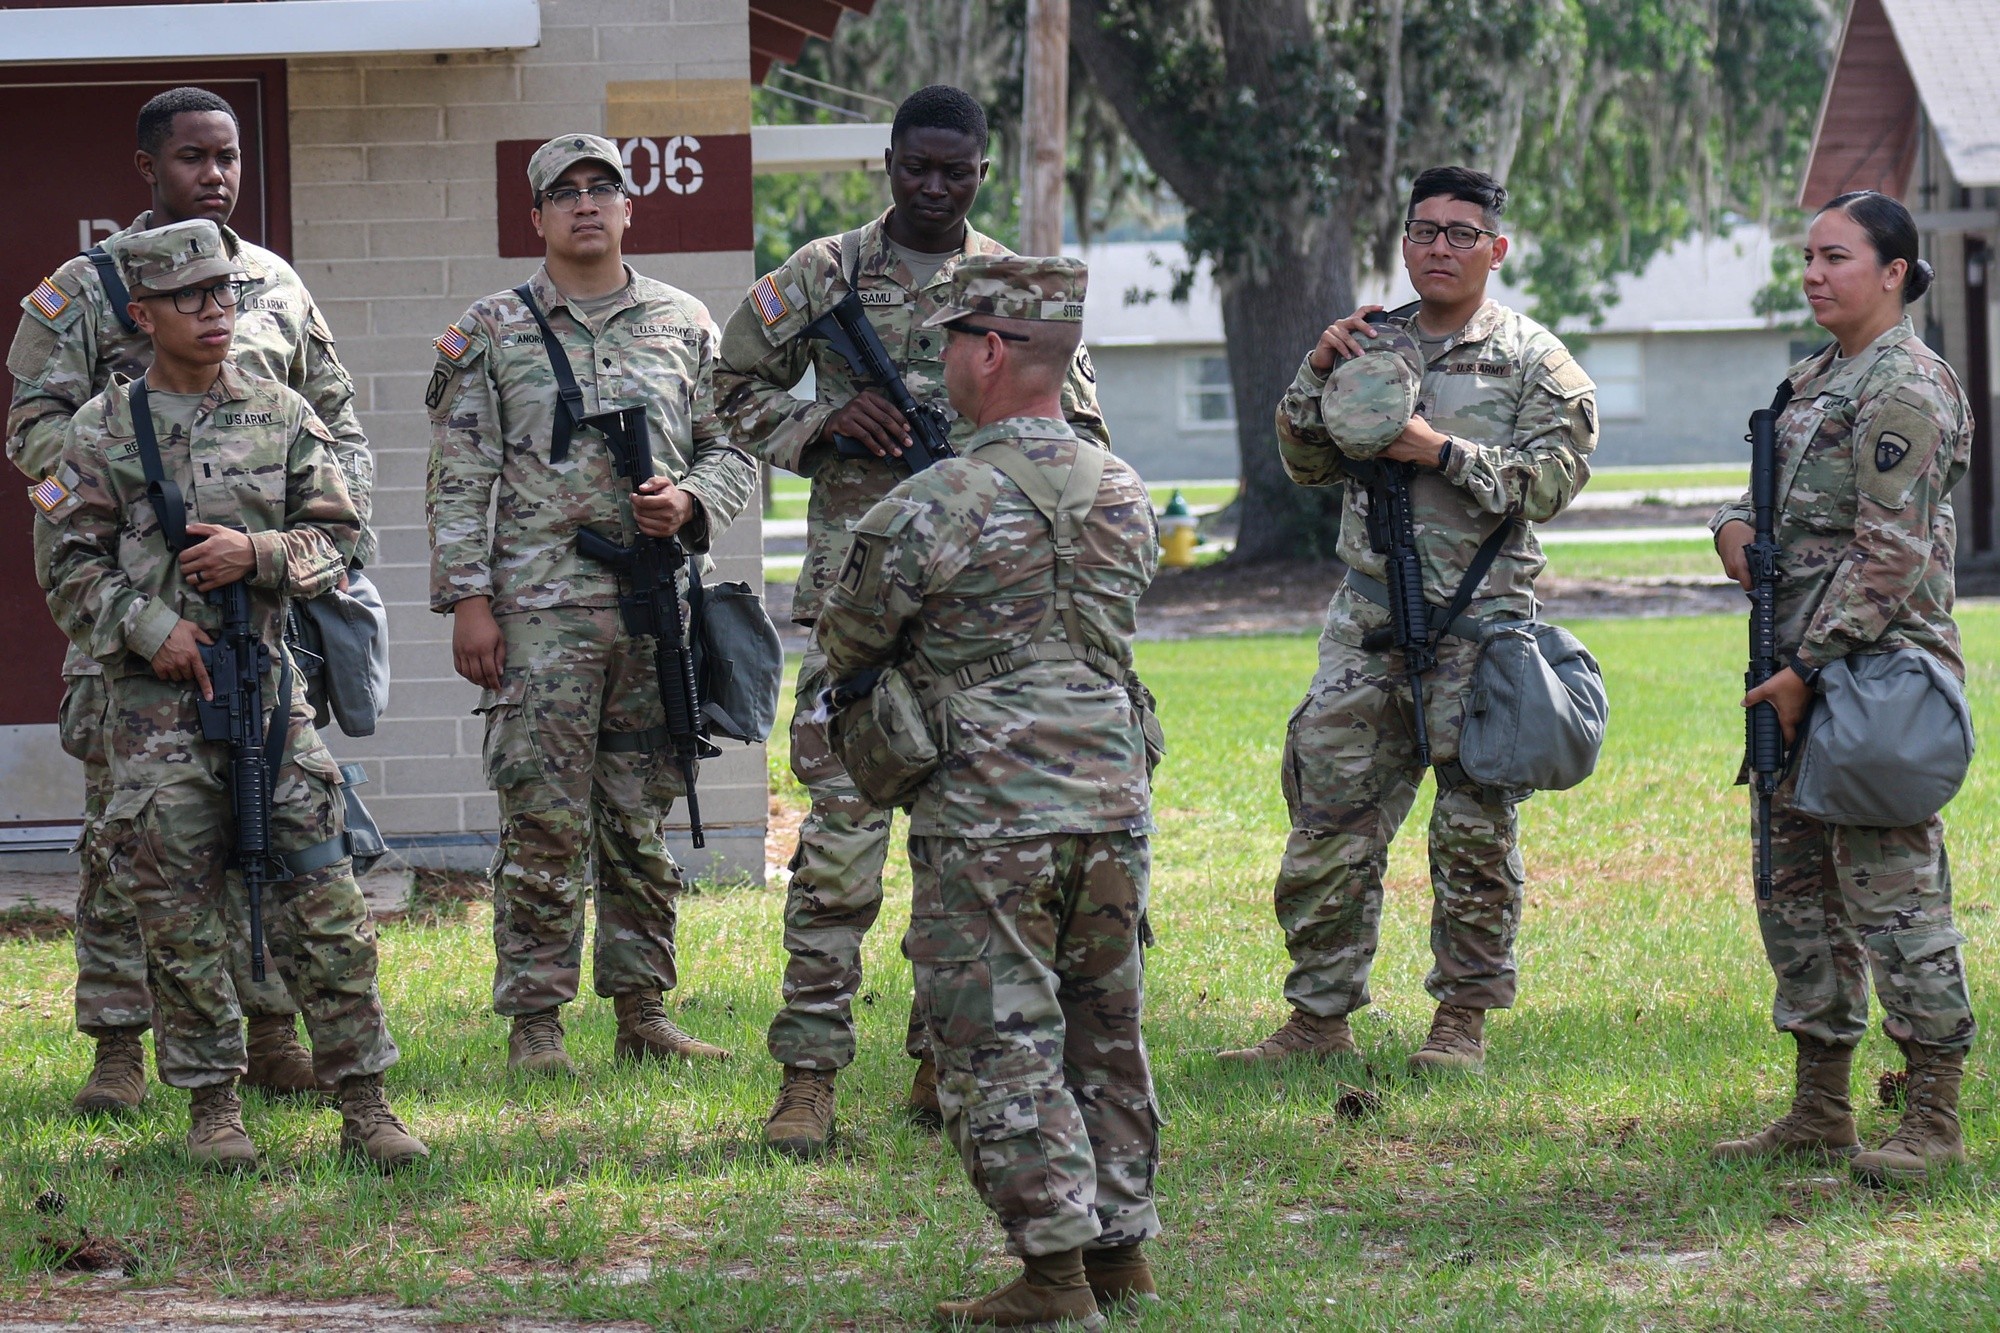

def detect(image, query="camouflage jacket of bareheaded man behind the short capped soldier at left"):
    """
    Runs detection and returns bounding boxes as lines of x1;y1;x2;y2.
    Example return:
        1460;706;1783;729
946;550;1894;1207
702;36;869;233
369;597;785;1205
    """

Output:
6;212;376;564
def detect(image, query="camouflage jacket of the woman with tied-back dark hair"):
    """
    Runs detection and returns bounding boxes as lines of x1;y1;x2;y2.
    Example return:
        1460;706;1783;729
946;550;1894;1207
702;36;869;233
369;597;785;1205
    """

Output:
1712;318;1972;677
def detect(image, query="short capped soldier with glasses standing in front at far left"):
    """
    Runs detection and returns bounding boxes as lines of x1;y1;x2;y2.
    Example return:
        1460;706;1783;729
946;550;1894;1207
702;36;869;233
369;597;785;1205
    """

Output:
36;218;428;1167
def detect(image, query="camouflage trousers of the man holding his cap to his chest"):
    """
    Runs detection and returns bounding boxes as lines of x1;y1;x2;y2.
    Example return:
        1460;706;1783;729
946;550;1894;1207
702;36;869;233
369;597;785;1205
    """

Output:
1274;632;1524;1019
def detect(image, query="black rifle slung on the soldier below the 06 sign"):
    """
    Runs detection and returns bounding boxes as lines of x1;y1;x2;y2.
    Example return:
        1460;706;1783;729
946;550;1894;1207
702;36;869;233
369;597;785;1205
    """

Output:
576;406;722;847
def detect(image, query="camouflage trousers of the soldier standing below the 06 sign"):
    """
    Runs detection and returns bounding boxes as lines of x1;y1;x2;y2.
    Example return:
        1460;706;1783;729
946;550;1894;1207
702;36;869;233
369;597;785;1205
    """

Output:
482;606;684;1015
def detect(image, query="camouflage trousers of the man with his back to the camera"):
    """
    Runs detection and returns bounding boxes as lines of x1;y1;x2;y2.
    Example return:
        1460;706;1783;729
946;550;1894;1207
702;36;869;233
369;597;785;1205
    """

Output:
904;833;1160;1255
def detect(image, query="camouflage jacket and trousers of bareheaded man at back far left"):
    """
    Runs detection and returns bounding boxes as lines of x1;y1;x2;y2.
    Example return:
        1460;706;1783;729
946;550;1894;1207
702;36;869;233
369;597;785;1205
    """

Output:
6;210;374;1035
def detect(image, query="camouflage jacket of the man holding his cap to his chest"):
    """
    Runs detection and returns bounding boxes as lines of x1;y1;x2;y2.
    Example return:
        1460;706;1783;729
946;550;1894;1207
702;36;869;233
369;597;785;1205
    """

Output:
1278;300;1598;644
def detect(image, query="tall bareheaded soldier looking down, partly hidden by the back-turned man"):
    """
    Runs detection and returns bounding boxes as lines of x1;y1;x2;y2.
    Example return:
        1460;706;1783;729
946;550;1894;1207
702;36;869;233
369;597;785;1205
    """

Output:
716;86;1110;1155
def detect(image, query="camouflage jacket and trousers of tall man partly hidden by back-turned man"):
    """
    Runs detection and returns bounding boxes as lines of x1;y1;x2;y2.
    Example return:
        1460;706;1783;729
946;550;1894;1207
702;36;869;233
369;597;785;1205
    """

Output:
716;214;1110;1071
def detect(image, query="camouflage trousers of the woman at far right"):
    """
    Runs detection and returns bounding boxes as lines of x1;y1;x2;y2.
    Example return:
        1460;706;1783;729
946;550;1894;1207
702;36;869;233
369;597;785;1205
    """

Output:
1750;779;1974;1051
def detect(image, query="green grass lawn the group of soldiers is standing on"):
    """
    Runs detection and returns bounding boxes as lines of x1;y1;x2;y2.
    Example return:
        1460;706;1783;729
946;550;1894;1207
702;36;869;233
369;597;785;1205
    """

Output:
0;606;2000;1331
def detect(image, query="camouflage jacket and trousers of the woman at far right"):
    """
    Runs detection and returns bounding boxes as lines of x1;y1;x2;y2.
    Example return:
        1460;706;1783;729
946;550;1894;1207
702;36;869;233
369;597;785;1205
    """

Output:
1712;318;1974;1051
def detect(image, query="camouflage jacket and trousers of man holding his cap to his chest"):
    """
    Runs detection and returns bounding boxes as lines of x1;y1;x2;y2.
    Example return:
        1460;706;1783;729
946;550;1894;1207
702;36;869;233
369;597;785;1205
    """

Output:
1274;300;1598;1019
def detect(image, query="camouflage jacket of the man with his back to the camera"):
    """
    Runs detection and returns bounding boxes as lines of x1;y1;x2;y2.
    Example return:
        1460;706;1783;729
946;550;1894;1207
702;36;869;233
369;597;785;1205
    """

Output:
814;418;1158;839
